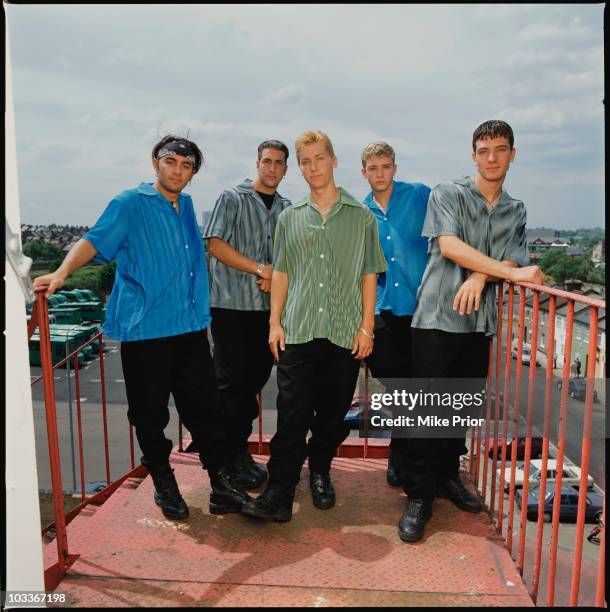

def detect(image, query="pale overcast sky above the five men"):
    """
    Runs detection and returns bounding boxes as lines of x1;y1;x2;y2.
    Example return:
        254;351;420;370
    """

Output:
5;4;605;229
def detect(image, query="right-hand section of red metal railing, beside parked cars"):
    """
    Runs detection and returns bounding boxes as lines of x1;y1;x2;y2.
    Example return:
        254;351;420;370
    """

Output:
470;283;605;606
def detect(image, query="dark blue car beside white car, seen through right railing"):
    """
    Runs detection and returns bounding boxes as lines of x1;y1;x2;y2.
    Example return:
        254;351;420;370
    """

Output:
515;482;603;523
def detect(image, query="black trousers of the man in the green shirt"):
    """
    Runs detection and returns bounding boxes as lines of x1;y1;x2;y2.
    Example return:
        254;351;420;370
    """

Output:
268;339;360;488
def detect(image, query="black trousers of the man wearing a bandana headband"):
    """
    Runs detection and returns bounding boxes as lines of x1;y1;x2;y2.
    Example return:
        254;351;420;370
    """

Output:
121;330;232;470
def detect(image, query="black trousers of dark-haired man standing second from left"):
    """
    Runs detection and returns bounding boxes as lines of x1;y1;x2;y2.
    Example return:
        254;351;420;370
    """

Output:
211;308;273;453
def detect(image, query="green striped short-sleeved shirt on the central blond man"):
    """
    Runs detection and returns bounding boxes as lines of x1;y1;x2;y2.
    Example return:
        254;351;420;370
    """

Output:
273;188;387;349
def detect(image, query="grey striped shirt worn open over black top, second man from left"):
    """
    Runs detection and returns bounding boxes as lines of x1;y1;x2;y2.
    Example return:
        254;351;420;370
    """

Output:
203;179;290;310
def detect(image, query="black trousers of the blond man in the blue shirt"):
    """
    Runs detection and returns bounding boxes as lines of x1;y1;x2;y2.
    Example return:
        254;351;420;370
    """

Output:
366;310;413;465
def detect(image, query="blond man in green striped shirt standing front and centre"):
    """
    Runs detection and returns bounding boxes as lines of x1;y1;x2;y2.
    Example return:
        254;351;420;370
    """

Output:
239;131;386;521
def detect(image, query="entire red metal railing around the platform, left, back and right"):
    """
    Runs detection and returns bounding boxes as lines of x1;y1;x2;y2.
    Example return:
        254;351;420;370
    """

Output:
28;283;605;606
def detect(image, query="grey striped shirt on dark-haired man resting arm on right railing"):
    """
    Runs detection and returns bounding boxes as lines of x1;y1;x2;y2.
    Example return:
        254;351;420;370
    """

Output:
411;176;529;336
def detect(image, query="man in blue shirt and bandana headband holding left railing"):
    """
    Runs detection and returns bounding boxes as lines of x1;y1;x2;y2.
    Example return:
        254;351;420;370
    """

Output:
34;135;248;519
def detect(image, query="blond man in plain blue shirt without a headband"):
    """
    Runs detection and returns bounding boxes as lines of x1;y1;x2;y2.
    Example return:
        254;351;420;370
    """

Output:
361;142;430;486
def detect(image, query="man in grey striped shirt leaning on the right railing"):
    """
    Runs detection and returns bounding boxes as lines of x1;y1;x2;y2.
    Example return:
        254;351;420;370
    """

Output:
398;121;543;542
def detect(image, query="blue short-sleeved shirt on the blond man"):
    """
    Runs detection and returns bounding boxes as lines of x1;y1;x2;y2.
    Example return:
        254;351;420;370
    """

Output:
364;181;430;316
